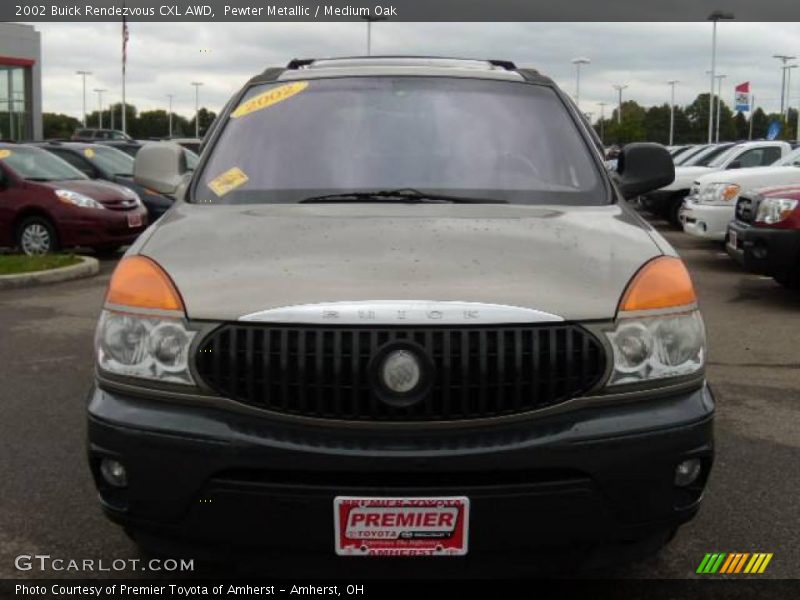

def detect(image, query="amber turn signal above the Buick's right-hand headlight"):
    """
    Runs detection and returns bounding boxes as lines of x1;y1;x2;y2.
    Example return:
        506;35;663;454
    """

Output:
619;256;697;311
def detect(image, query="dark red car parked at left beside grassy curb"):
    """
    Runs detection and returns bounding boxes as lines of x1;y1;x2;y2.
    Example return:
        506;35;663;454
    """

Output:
0;144;147;254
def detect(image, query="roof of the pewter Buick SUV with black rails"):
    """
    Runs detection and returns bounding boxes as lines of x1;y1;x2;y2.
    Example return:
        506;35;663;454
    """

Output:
260;56;550;83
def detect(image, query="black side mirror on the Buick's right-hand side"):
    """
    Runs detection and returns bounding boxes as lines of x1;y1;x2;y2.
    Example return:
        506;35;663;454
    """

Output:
617;142;675;200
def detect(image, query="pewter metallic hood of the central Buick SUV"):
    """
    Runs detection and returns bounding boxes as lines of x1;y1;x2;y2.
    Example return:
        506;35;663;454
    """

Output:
139;202;668;320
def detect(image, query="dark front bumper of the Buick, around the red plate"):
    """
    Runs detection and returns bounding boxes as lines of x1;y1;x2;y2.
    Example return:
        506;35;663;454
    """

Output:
84;385;714;560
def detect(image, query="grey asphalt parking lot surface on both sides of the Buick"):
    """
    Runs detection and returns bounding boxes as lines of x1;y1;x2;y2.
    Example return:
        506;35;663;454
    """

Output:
0;214;800;578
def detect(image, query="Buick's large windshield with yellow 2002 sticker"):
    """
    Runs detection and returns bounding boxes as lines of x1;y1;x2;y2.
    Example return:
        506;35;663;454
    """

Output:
195;77;607;204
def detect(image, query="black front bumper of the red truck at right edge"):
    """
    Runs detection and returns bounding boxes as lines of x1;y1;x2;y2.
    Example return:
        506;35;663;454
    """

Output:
726;221;800;278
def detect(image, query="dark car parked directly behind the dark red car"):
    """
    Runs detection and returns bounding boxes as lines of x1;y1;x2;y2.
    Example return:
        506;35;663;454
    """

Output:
32;141;173;223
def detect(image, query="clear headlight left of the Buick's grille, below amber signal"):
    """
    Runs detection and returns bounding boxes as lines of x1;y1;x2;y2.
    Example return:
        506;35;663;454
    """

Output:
95;310;195;385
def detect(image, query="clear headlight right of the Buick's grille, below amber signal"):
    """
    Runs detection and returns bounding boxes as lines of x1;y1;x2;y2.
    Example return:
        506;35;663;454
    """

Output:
606;310;706;385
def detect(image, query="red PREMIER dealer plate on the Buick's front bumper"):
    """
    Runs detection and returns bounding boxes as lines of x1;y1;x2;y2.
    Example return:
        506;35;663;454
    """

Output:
333;496;469;556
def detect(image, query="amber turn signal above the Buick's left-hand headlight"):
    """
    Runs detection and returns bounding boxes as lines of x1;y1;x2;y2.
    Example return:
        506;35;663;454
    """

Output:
106;256;183;311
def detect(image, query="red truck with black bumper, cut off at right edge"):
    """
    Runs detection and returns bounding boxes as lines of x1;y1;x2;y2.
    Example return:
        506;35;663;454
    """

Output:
726;185;800;289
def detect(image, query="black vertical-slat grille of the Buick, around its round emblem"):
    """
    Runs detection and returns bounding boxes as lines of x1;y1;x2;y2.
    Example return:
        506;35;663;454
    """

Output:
195;323;606;422
